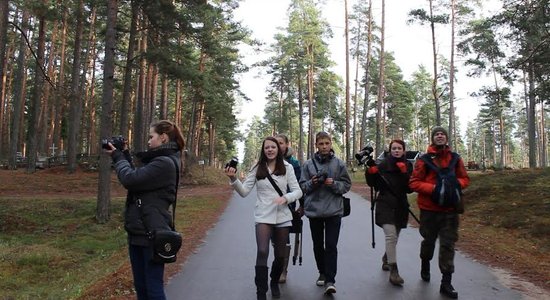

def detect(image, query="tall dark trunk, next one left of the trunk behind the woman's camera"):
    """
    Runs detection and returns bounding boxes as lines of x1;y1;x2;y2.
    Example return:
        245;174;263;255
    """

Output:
67;0;84;173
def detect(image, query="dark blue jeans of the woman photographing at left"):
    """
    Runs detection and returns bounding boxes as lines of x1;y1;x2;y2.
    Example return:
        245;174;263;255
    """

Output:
128;245;166;300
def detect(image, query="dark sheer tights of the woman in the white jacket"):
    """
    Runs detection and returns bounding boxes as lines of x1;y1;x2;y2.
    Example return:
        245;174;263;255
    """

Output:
256;223;289;266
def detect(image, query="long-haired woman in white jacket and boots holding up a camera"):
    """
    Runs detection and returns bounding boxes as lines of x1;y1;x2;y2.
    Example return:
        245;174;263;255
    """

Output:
225;137;302;300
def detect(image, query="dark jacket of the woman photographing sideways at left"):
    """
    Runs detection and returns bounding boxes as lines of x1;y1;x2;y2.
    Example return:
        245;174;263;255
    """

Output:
113;149;180;246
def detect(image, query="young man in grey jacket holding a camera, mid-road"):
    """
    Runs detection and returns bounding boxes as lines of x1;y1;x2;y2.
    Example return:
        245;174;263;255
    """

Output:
300;132;351;294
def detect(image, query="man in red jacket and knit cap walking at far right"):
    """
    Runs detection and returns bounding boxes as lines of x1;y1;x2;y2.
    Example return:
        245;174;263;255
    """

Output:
409;126;470;299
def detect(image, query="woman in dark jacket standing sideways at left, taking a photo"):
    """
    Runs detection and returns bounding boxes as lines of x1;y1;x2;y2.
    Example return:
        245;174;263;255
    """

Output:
105;120;185;300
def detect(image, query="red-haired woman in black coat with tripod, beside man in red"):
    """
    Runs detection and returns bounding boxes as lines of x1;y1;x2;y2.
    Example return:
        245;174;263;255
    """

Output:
366;140;412;285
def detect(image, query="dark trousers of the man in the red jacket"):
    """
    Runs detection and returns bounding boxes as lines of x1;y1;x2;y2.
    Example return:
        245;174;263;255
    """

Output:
420;210;458;273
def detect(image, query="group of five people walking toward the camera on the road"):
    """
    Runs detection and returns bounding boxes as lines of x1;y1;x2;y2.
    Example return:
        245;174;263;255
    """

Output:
225;126;469;299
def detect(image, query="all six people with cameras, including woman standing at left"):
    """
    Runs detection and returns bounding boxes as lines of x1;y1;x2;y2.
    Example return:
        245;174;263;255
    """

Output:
105;120;469;299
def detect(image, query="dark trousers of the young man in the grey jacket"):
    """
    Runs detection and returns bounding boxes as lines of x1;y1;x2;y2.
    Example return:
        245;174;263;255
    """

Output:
309;216;342;283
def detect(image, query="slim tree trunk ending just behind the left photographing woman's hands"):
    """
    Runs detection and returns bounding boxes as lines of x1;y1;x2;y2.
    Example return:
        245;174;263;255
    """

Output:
119;0;139;136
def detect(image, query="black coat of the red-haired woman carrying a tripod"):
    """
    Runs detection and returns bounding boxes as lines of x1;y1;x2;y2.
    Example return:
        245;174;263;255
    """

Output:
365;159;412;228
